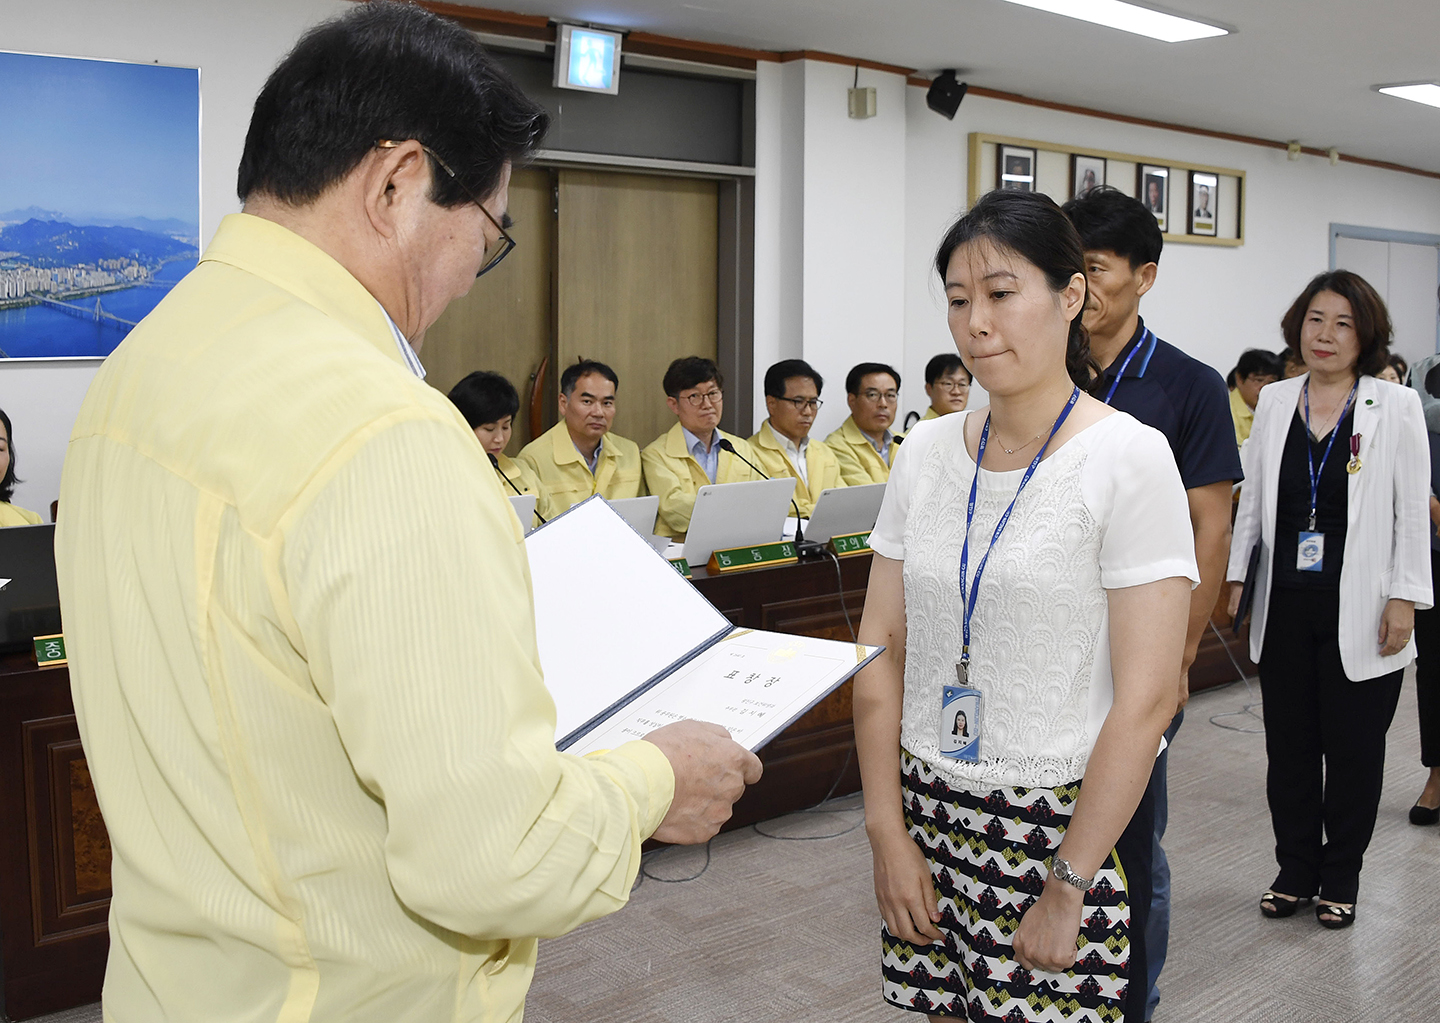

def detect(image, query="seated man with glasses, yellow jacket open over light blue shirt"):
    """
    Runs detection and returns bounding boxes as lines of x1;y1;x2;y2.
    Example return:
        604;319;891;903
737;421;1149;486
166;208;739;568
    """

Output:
639;356;760;540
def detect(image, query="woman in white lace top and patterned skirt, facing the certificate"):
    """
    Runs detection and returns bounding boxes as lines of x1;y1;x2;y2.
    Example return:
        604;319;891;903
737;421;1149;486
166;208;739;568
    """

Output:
855;192;1198;1022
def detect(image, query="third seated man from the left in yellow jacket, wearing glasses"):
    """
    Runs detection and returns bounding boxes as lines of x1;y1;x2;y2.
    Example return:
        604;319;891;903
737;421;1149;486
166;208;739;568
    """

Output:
750;359;845;519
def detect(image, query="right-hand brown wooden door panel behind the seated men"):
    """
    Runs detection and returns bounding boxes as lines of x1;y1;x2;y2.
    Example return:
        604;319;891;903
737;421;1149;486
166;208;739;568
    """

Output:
556;170;720;447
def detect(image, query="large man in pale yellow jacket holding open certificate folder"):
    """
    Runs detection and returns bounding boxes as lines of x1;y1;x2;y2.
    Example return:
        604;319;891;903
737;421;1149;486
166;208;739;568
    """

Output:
55;3;759;1023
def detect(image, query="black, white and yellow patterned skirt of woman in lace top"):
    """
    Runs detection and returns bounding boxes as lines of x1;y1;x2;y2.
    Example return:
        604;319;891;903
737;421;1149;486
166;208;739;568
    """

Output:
881;749;1151;1023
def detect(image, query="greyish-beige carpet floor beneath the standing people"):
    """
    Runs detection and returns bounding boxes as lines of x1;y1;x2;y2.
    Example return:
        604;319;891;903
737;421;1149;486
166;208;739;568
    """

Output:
28;680;1440;1023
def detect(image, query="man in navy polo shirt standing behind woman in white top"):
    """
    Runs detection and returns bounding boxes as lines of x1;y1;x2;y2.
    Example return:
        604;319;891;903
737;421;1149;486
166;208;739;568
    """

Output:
1064;186;1243;1019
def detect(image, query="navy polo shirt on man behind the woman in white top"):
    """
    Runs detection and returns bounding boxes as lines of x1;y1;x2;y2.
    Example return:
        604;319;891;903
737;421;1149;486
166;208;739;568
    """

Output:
1090;320;1244;490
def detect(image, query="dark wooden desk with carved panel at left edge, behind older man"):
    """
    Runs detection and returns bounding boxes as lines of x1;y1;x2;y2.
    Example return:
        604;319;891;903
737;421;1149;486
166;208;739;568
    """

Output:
0;656;109;1020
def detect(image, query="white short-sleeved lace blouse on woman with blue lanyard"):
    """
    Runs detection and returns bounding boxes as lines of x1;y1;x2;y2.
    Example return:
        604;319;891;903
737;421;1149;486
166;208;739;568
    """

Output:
870;412;1200;792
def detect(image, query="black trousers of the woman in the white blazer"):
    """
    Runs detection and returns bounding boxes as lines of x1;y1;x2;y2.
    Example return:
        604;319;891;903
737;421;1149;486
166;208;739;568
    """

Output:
1260;588;1404;902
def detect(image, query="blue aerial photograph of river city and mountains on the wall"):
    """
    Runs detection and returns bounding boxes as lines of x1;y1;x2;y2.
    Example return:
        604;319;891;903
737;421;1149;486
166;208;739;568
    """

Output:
0;52;200;359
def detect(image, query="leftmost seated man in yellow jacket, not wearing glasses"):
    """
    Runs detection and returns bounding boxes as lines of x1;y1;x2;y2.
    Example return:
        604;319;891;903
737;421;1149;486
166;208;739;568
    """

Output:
517;359;645;519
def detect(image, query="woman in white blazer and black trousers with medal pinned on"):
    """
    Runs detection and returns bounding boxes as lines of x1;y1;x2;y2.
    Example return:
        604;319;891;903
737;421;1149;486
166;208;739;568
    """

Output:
1227;271;1433;929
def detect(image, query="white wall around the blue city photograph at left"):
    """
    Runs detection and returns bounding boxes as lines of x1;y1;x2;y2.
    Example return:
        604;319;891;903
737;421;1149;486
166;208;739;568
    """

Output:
0;0;350;519
